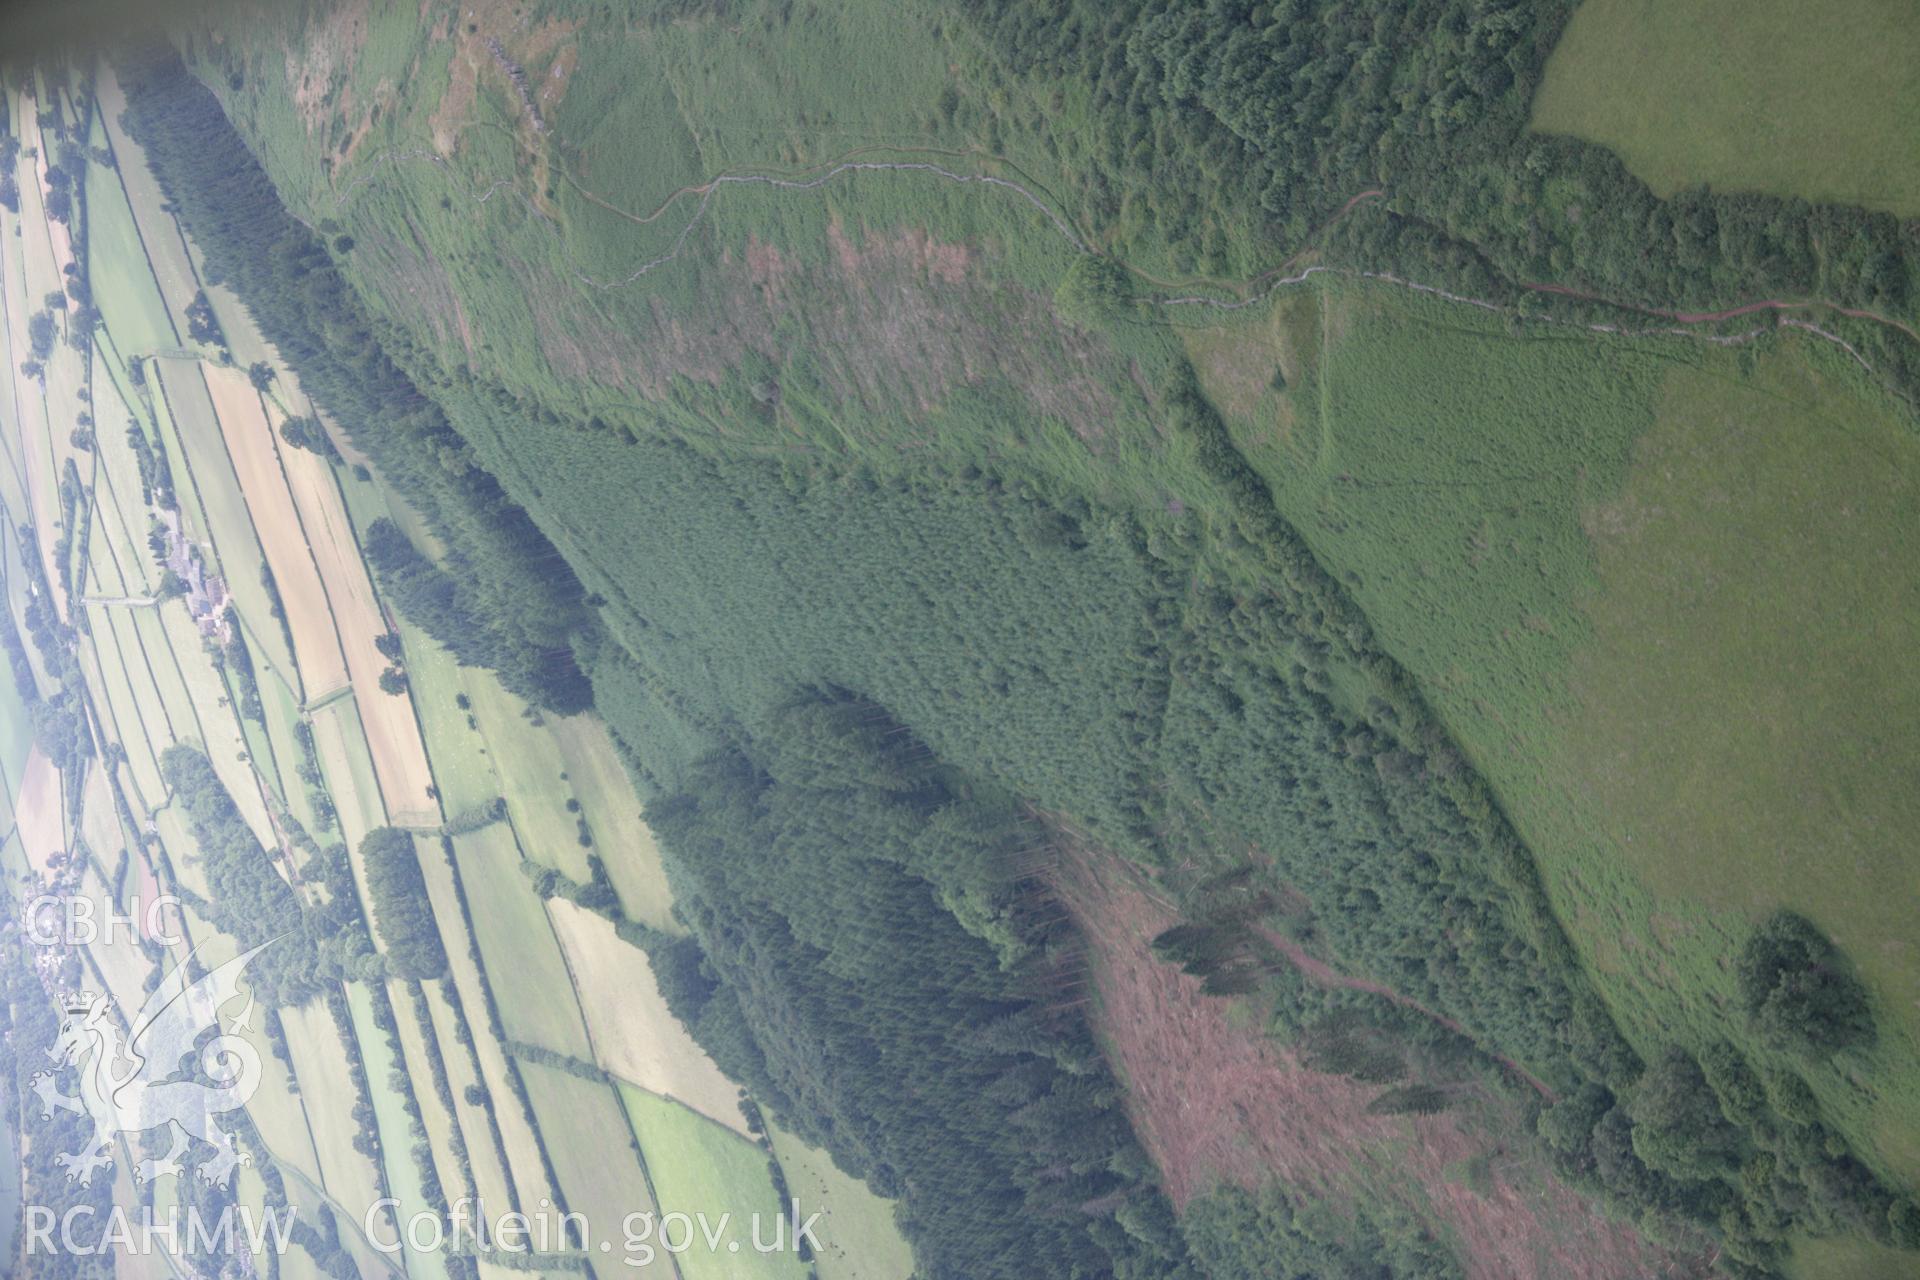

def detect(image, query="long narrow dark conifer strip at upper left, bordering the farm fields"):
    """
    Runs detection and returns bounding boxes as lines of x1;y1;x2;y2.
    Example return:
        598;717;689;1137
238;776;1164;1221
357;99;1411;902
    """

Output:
115;48;591;714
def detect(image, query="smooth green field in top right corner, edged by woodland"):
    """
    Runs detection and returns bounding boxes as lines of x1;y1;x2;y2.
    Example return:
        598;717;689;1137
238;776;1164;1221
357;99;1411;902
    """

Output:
1534;0;1920;213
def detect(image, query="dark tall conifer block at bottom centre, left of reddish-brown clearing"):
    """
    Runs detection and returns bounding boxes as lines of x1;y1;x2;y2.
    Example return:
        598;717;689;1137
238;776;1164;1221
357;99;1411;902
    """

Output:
649;693;1187;1280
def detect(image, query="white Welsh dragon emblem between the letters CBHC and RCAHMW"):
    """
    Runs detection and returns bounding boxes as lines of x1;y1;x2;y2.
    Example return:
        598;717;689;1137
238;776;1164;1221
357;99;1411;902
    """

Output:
33;942;273;1188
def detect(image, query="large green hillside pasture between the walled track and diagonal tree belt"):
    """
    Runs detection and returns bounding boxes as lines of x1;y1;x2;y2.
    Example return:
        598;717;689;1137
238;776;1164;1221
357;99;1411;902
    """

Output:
1200;278;1920;1220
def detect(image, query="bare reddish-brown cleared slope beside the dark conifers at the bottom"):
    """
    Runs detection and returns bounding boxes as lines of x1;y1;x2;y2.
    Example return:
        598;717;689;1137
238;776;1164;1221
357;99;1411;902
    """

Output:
1054;839;1709;1280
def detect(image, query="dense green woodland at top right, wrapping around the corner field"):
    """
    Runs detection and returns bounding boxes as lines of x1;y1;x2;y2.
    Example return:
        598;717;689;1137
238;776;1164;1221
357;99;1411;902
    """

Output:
952;0;1920;397
